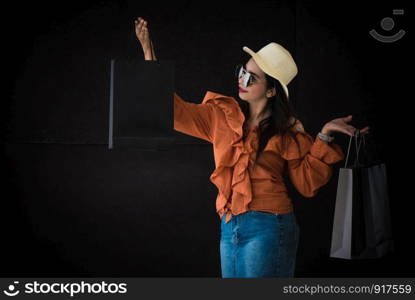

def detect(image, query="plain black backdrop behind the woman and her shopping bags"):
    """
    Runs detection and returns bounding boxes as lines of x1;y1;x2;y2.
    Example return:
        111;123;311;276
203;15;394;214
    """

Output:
0;1;414;277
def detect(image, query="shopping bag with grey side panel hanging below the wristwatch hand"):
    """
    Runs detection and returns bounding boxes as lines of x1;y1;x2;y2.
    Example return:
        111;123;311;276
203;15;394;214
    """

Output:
330;130;394;259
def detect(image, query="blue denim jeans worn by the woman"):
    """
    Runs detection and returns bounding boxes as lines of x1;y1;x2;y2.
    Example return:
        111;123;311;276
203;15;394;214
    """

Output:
220;211;300;278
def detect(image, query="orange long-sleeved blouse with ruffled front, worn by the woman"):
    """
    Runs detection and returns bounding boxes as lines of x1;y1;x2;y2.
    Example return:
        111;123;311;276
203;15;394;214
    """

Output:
174;91;344;223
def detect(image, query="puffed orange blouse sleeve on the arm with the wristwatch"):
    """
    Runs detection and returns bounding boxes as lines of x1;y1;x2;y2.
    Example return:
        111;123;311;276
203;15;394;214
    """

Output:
282;132;344;197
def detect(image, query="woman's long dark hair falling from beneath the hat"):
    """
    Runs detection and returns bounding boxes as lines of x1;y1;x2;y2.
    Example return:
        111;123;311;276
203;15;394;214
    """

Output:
238;73;299;160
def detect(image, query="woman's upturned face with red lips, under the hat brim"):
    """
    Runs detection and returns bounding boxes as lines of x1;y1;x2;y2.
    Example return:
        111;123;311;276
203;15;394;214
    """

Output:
238;57;273;102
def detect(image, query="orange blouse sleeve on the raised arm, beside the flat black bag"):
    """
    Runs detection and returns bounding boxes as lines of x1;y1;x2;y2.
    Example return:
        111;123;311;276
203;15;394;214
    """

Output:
174;93;217;142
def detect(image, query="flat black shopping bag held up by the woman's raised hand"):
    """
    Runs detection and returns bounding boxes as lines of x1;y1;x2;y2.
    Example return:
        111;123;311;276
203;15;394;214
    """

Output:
108;58;175;149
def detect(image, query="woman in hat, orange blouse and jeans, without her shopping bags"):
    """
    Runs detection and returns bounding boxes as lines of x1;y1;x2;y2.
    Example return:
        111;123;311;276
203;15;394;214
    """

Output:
135;18;369;278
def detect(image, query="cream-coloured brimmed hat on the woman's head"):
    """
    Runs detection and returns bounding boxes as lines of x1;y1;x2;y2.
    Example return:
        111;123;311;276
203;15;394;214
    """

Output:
242;42;298;98
